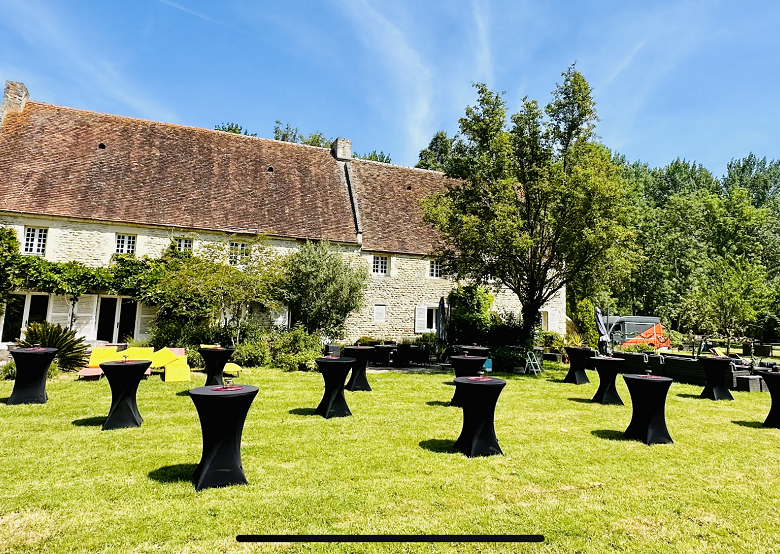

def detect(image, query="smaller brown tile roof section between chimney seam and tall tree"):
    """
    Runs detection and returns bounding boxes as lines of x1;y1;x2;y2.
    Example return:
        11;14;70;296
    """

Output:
349;160;455;255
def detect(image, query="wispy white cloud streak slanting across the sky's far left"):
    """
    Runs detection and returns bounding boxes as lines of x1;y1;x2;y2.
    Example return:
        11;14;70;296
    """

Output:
5;0;176;121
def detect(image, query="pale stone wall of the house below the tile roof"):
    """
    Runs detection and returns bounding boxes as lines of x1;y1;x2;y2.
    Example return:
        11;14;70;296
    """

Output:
0;214;566;342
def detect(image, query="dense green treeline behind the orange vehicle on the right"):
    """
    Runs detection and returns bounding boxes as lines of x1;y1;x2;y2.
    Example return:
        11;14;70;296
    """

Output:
567;153;780;341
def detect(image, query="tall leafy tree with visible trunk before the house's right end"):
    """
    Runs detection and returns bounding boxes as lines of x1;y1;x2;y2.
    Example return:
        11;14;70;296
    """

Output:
423;66;631;346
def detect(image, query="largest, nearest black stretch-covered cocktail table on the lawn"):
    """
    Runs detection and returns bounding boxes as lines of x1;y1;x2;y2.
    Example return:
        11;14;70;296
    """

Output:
190;385;258;491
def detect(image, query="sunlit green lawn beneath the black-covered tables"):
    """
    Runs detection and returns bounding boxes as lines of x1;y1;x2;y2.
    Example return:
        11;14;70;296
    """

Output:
0;367;780;553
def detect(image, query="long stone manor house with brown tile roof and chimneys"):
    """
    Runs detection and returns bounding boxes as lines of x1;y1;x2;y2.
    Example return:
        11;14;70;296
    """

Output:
0;81;566;344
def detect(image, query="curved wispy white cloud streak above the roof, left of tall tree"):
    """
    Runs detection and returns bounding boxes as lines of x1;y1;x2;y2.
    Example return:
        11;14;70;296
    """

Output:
338;0;433;159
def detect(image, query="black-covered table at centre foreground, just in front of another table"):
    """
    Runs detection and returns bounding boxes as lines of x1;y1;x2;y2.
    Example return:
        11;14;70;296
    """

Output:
455;377;506;458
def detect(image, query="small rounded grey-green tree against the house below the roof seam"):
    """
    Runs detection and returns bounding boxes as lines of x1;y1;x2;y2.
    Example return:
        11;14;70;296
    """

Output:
280;241;368;338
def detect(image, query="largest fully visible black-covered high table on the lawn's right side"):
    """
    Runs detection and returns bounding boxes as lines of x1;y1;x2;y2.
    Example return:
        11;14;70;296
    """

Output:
623;374;673;444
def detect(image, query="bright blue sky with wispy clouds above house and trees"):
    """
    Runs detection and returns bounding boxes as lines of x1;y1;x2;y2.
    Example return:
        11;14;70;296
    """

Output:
0;0;780;172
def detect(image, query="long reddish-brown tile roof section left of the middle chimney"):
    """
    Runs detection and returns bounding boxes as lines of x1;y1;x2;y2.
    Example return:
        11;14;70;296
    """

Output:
0;101;356;243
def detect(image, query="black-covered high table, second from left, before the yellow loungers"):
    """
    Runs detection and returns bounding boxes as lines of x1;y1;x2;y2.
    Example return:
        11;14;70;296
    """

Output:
100;360;152;431
